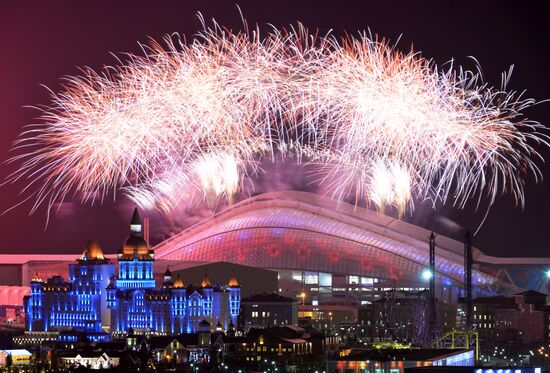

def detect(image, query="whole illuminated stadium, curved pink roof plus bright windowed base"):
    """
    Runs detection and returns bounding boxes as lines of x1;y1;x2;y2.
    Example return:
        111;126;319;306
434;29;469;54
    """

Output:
154;192;548;304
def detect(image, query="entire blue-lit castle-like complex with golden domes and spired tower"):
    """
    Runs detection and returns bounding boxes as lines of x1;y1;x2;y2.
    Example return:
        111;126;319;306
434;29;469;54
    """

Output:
24;209;241;342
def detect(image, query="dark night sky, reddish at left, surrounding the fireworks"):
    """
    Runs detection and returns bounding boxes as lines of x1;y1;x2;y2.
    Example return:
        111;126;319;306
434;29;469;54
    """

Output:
0;0;550;256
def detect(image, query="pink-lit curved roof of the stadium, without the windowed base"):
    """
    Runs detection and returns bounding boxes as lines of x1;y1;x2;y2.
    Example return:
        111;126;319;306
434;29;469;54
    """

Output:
154;192;495;285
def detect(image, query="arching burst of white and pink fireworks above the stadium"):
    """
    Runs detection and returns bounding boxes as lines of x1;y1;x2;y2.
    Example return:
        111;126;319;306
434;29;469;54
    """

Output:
7;16;548;212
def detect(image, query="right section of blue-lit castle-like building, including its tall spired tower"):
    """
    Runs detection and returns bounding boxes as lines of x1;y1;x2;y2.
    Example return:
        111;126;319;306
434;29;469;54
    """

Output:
107;210;241;334
